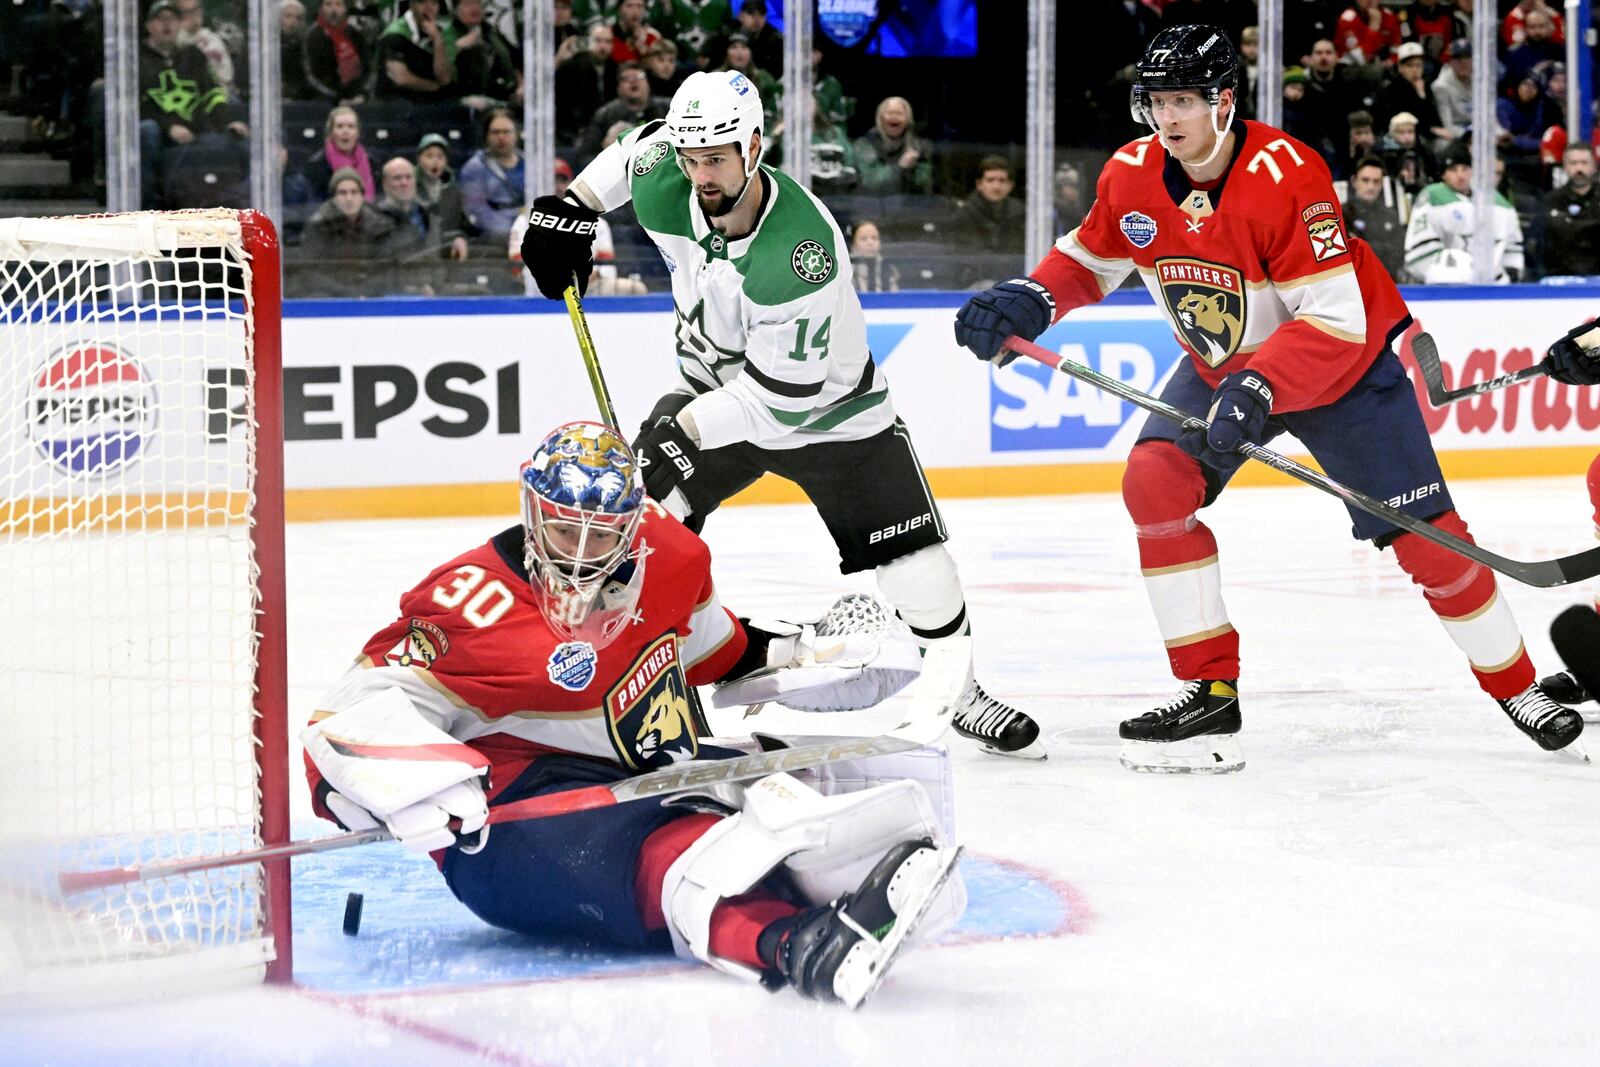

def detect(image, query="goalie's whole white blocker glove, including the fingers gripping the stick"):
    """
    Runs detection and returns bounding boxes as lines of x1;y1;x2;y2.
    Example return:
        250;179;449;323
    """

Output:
301;688;490;853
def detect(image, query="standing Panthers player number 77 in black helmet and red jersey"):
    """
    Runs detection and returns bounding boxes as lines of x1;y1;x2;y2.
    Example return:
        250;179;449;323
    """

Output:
955;26;1582;771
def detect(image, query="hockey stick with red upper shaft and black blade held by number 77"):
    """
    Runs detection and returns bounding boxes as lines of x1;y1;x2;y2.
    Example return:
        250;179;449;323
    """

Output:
1005;338;1600;589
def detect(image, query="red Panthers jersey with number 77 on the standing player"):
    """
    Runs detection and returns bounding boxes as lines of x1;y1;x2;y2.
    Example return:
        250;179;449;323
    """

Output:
1032;122;1411;413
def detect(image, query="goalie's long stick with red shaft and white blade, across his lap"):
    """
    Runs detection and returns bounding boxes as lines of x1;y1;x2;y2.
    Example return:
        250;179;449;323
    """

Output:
56;638;973;894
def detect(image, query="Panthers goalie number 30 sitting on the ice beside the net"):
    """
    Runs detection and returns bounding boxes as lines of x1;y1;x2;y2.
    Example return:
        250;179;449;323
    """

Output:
302;422;965;1005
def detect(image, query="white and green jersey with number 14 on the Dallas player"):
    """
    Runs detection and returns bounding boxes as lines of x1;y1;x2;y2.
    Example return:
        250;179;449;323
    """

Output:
571;122;894;448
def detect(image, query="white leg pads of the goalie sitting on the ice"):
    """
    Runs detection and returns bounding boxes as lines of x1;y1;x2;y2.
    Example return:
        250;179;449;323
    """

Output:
661;774;966;977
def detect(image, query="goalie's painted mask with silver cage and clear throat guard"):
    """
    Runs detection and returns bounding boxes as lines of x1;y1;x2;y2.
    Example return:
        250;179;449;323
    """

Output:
522;422;645;649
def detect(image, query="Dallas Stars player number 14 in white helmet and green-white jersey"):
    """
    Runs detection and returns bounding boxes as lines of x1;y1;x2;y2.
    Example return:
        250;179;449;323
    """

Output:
522;70;1045;758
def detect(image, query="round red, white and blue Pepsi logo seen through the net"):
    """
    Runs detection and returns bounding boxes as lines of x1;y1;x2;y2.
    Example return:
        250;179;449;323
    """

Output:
27;344;157;475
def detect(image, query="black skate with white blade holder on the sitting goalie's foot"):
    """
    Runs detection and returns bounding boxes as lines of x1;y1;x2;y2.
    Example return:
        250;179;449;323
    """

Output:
762;838;962;1009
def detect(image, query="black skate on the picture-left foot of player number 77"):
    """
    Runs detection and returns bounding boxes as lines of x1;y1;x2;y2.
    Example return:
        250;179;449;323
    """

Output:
1117;678;1245;774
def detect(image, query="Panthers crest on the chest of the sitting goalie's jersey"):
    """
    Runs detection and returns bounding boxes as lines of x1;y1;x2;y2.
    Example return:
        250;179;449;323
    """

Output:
605;633;699;771
